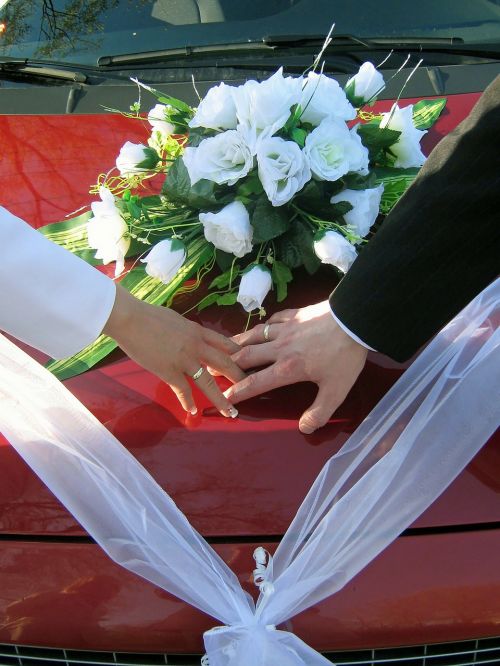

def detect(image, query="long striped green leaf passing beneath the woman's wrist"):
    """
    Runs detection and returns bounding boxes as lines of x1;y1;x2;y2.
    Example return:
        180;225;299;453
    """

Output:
46;237;213;380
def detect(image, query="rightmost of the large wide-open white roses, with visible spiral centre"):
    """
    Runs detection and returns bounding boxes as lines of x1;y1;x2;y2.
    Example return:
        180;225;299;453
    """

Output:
304;118;368;181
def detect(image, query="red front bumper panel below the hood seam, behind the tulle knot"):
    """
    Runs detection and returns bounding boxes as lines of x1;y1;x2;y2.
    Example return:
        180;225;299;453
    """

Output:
0;530;500;653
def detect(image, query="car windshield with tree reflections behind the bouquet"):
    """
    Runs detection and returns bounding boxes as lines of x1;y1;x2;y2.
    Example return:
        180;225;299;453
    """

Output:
0;0;500;65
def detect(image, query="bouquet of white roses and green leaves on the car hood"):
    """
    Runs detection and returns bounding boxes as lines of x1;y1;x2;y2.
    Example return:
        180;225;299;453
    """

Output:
41;62;445;378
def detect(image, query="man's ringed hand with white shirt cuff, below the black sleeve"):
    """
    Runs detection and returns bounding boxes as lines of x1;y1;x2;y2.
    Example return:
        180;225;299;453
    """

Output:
225;301;368;434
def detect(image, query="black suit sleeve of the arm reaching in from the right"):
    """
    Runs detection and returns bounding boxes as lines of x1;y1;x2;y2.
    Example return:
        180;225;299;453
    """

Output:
330;76;500;361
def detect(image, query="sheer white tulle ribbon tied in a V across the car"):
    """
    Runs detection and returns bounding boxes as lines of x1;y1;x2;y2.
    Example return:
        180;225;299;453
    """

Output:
0;280;500;666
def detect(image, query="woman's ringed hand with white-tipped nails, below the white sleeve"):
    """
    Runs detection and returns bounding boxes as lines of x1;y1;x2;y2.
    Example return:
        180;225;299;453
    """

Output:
103;285;245;418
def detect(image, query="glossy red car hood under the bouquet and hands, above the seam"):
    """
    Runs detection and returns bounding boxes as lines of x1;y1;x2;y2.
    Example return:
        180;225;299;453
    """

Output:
0;94;500;538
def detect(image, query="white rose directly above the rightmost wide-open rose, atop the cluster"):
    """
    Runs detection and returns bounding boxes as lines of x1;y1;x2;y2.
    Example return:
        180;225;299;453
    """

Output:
300;72;356;125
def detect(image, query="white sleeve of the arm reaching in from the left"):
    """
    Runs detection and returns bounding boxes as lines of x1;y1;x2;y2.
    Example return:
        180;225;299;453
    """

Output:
0;207;116;359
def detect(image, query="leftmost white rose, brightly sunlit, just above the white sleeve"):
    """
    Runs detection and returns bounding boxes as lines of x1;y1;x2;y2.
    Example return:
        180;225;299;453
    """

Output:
87;187;130;276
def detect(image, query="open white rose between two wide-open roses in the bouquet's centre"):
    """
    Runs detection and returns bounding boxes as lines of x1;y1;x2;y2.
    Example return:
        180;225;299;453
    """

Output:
257;136;311;206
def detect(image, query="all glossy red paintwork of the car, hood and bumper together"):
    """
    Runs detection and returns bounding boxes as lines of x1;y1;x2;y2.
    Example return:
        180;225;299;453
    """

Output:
0;88;500;653
